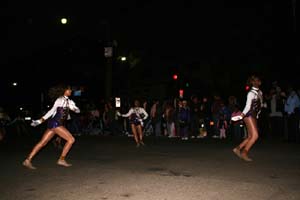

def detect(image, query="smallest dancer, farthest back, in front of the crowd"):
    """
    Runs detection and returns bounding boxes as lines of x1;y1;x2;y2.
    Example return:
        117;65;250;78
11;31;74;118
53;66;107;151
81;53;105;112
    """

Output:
117;100;148;147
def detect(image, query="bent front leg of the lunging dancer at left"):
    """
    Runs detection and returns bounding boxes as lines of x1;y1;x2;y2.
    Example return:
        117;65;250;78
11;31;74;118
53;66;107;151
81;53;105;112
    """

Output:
55;126;75;167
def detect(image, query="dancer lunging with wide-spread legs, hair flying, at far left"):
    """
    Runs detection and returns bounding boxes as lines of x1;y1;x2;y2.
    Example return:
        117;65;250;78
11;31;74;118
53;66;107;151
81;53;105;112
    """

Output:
23;85;80;169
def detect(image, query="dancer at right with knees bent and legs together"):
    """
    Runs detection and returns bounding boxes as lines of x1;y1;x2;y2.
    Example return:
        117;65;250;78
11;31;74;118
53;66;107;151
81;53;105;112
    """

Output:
231;75;263;161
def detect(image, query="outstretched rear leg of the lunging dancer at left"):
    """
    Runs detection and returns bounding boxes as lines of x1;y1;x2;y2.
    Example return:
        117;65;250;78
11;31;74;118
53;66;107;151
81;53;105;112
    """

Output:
23;129;55;169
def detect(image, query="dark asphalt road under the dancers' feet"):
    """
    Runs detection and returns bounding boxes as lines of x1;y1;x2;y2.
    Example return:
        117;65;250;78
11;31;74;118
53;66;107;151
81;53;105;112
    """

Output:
0;136;300;200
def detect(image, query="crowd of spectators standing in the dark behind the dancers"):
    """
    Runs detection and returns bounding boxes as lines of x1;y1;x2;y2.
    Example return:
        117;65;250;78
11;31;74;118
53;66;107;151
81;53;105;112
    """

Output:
0;82;300;142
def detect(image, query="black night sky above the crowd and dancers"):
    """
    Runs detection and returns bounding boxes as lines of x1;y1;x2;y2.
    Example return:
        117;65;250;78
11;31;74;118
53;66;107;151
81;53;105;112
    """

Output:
0;0;297;110
